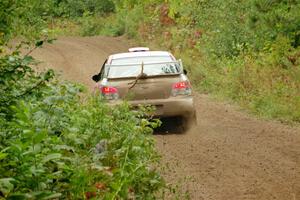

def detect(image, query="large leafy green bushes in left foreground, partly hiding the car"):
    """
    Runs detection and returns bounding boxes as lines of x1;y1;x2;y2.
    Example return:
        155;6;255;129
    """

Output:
0;42;163;199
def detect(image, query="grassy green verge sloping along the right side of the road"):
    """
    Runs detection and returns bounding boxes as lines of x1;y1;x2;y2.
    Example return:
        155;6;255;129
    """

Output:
193;37;300;122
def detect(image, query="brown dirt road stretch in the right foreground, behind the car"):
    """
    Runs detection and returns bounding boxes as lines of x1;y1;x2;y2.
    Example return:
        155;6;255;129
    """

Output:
157;94;300;200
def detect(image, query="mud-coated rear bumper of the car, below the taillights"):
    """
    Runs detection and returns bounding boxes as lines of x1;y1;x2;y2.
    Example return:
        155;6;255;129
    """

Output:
112;96;195;117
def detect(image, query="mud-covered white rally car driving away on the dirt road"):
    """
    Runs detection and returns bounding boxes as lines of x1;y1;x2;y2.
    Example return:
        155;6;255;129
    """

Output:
95;51;194;128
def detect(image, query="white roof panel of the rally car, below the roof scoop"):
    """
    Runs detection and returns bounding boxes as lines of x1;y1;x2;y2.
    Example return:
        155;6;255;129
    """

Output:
109;51;173;60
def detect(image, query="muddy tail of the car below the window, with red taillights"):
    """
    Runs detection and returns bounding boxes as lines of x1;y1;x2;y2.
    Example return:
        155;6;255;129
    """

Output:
105;75;194;117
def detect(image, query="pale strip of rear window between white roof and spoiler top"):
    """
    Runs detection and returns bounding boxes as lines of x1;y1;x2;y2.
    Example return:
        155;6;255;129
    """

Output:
111;56;173;65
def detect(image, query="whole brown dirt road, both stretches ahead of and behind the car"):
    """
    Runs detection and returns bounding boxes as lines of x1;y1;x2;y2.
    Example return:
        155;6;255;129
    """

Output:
33;37;300;200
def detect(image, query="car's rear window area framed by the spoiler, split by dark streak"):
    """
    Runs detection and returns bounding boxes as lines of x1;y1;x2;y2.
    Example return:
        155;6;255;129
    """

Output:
107;62;181;78
